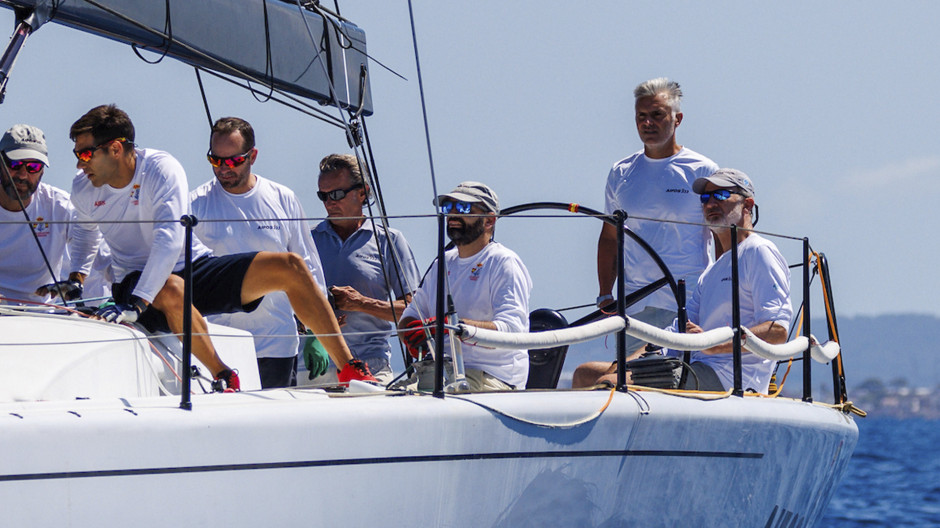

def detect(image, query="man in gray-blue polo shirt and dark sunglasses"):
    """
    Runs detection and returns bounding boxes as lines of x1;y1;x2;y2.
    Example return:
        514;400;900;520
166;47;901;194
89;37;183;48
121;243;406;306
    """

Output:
312;154;421;383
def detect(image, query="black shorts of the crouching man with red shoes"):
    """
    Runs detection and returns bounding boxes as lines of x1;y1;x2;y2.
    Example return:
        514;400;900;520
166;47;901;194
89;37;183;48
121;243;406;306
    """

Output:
111;252;264;332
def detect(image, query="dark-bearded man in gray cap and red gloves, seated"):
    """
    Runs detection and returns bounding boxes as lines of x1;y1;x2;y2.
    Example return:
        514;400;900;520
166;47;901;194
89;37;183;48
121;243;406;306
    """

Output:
398;182;532;391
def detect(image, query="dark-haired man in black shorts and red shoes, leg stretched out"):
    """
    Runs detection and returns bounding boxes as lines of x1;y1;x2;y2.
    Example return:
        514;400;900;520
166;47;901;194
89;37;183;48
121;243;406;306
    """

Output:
69;105;374;390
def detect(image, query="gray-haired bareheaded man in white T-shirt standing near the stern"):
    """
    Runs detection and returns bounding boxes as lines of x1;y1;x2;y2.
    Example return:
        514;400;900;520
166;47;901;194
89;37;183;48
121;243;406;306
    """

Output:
573;77;718;387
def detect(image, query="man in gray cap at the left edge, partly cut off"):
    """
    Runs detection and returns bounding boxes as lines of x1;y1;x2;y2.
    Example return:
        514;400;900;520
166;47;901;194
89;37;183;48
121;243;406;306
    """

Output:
0;125;97;303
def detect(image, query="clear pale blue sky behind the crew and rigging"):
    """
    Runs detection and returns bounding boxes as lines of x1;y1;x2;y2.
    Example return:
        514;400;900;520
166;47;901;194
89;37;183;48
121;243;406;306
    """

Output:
0;0;940;315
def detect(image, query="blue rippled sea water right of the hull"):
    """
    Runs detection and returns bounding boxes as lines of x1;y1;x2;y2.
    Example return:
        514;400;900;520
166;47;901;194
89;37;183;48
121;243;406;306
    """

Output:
818;418;940;528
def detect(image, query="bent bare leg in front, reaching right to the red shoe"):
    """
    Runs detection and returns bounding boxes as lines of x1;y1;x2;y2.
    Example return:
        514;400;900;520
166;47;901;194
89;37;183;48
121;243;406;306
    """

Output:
242;251;352;369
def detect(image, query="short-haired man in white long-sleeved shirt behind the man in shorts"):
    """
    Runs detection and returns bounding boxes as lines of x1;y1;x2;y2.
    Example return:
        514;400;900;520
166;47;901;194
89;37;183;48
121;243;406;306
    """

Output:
189;117;324;389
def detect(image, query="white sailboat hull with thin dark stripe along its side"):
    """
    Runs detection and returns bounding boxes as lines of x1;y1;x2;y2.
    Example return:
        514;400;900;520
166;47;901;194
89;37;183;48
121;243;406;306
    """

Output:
0;390;858;527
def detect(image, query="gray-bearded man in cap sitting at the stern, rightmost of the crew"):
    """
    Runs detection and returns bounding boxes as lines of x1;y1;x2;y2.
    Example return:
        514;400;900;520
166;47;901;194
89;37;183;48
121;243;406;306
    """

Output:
573;169;793;393
